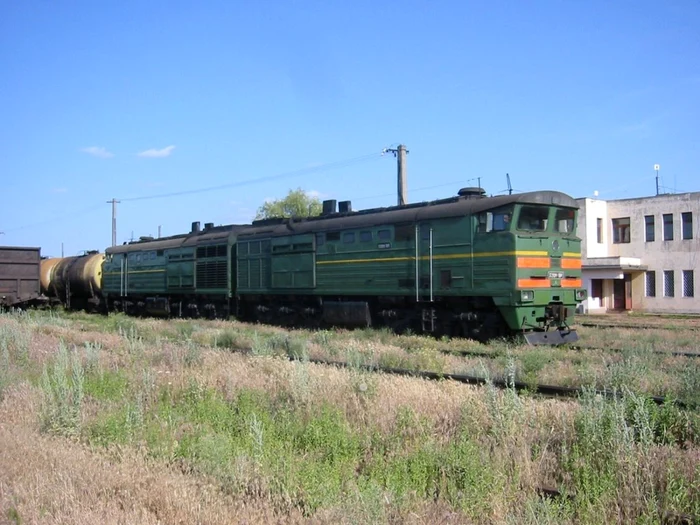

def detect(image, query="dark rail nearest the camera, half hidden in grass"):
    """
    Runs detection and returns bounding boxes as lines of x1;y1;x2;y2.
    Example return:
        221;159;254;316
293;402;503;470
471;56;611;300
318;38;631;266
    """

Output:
289;356;692;409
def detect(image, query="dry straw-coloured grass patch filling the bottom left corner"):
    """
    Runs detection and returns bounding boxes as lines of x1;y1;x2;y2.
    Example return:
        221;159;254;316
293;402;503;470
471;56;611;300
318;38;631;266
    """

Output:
0;384;302;525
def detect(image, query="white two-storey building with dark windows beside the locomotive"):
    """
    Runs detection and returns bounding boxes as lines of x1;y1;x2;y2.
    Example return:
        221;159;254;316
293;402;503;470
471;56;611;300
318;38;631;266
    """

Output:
577;192;700;313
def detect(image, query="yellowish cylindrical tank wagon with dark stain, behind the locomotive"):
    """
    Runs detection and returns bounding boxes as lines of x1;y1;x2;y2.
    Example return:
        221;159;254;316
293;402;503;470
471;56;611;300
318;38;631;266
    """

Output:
41;251;105;311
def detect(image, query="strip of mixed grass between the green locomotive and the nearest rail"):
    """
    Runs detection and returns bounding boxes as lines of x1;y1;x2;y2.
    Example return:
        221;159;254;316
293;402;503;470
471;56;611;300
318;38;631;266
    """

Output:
5;313;700;406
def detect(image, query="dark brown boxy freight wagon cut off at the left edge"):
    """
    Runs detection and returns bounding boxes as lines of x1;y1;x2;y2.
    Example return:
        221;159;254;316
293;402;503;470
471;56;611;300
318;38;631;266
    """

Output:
0;246;44;308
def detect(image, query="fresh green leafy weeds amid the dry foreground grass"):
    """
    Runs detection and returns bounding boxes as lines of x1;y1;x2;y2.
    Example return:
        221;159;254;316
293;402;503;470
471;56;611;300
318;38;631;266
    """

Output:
78;372;700;523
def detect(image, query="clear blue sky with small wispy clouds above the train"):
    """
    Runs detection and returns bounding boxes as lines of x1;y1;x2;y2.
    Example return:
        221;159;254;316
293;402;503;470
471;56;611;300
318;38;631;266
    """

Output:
0;0;700;256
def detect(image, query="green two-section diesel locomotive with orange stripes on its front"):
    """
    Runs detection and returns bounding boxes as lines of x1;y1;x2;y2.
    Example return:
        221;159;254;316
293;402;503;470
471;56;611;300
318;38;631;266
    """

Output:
102;188;586;344
